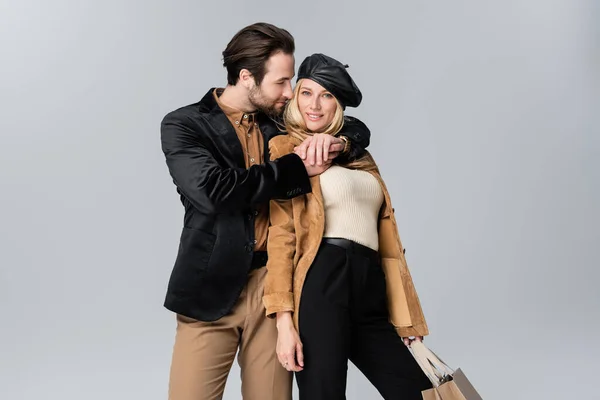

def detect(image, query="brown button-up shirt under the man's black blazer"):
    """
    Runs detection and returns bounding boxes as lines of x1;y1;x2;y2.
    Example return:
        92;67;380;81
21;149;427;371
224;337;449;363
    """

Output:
214;89;269;251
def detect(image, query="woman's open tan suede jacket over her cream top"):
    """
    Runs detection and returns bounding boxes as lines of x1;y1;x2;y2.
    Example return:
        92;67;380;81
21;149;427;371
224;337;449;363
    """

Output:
263;135;429;337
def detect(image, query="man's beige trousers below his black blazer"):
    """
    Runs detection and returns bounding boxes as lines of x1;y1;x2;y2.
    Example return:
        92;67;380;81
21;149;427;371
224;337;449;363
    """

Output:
169;268;292;400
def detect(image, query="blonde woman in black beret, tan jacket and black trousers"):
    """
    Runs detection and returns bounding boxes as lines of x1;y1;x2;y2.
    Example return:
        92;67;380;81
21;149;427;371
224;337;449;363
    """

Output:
263;54;431;400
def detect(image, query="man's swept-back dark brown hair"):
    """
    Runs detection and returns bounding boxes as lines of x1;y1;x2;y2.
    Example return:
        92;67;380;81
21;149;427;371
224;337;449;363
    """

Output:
223;22;295;85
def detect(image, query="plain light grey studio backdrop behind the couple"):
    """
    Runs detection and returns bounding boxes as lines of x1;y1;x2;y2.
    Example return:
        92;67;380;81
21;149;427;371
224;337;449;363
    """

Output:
0;0;600;400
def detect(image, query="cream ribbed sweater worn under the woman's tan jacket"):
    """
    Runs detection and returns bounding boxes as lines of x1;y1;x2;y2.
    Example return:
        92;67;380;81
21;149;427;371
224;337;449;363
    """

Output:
320;165;383;250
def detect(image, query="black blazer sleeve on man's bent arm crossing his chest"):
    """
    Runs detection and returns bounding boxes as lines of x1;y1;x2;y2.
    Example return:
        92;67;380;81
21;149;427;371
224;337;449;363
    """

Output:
161;111;311;212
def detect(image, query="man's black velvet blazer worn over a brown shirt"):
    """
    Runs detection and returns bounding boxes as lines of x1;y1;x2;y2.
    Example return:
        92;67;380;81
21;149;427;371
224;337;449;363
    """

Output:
161;88;370;321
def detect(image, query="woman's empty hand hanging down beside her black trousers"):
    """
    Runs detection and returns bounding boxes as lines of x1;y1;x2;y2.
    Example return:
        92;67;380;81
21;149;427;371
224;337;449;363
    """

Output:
277;311;304;372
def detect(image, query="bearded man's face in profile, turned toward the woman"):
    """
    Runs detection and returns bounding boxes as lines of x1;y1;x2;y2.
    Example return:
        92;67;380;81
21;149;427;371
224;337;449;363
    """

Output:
248;52;294;116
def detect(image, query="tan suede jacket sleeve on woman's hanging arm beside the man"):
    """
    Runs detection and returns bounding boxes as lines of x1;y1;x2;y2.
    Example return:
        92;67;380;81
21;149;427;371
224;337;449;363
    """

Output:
263;142;296;318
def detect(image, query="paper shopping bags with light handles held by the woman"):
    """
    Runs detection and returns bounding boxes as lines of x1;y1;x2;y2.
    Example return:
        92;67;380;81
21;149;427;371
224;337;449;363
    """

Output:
410;341;483;400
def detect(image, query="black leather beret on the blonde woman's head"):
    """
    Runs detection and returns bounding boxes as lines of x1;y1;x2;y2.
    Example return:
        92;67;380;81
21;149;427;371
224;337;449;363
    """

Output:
297;53;362;109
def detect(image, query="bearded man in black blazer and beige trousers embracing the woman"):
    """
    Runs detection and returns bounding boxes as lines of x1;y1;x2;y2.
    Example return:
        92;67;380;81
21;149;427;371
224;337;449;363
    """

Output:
161;23;370;400
